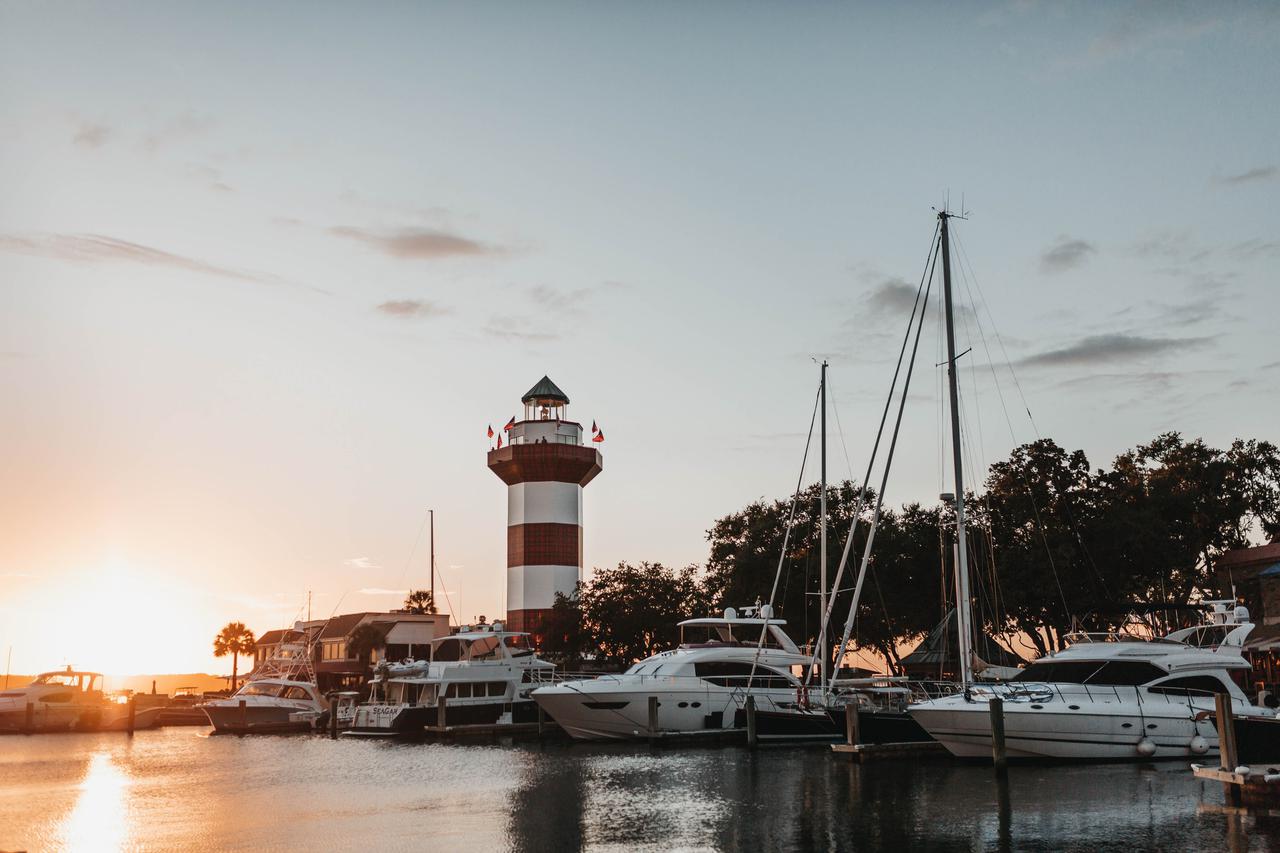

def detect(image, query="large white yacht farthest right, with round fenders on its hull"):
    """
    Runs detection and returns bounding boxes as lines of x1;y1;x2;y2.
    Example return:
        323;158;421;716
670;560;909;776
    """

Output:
909;601;1274;761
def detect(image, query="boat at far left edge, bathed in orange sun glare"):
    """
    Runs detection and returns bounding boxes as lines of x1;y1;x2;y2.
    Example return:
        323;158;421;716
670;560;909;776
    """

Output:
0;666;160;734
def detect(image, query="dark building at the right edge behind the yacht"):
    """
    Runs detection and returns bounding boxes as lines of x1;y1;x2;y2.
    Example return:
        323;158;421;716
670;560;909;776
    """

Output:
1213;539;1280;693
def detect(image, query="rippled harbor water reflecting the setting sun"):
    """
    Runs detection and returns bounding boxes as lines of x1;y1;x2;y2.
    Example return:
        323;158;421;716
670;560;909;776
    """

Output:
0;727;1280;852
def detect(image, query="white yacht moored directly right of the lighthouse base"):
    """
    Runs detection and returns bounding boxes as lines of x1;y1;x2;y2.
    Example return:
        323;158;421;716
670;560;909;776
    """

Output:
532;605;809;740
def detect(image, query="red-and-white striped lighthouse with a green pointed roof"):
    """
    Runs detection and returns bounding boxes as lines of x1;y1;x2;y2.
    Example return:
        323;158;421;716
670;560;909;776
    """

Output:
489;377;602;635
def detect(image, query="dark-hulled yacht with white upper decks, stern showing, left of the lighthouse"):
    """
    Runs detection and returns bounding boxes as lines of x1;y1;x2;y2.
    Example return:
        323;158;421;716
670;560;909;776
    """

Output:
346;622;556;736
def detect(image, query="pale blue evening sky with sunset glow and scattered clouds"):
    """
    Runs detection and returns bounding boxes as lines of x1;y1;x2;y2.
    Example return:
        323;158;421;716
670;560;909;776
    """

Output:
0;1;1280;674
